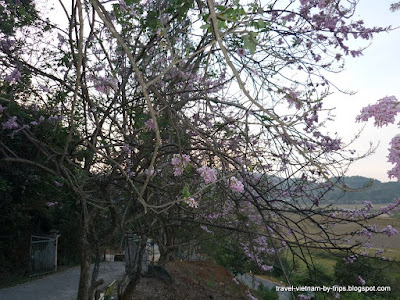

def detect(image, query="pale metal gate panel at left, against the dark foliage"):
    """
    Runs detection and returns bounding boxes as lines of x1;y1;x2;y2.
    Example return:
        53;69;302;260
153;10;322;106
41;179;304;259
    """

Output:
30;235;57;276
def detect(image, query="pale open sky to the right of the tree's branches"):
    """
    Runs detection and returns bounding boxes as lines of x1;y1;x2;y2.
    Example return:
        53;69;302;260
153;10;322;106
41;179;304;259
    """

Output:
324;0;400;182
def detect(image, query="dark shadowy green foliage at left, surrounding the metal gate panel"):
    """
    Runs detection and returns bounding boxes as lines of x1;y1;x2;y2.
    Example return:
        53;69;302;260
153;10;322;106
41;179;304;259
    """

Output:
0;102;82;271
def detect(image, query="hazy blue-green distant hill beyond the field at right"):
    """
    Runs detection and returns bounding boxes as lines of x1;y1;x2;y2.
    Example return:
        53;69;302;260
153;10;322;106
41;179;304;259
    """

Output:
324;176;400;203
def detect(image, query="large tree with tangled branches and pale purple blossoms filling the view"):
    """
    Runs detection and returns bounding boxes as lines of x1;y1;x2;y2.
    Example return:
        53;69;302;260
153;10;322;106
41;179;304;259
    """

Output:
0;0;397;299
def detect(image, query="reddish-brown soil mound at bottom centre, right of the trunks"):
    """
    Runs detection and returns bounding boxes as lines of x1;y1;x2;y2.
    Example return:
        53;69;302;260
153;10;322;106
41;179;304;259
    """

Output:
132;260;248;300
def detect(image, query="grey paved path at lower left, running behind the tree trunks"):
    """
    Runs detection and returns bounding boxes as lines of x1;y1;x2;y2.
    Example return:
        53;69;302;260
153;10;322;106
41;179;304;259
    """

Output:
0;262;125;300
